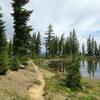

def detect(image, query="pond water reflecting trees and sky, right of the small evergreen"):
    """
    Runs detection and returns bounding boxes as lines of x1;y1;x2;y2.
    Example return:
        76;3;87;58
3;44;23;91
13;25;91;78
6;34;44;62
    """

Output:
80;60;100;79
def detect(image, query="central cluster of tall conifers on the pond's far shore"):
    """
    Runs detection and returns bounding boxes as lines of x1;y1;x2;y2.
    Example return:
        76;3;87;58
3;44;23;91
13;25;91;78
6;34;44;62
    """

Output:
45;24;79;57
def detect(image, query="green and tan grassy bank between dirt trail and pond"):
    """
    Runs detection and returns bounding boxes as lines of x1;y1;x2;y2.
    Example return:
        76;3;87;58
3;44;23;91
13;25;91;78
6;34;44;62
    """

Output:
35;59;100;100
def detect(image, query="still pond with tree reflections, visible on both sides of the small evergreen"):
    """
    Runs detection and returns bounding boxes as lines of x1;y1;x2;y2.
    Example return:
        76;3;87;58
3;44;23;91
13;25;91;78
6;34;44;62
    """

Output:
49;60;100;79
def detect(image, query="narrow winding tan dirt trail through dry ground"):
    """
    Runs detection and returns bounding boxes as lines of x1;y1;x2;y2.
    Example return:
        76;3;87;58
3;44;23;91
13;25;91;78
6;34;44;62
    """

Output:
28;62;45;100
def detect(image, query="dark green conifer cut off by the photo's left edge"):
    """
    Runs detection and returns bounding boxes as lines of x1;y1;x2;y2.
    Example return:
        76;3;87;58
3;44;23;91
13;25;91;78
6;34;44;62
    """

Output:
0;8;8;74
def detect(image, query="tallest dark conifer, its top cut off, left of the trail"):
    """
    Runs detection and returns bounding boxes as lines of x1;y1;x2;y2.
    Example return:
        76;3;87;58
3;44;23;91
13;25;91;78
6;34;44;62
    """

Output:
12;0;32;58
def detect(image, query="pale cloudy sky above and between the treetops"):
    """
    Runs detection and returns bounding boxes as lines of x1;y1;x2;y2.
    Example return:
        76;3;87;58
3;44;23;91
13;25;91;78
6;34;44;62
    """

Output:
0;0;100;47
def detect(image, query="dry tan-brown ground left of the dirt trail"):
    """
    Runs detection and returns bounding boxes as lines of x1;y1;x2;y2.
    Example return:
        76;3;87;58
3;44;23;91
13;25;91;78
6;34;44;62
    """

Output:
0;64;36;100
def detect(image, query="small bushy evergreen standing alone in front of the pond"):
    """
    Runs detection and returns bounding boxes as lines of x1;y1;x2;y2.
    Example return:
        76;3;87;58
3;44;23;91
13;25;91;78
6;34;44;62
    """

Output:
65;56;81;90
